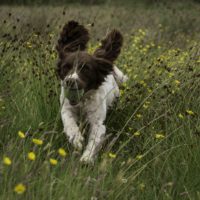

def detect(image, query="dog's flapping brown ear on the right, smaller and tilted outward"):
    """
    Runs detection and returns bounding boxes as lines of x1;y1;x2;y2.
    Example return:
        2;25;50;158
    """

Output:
94;29;123;62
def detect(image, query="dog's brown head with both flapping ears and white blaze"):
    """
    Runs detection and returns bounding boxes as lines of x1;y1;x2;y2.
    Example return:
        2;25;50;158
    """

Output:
56;21;123;91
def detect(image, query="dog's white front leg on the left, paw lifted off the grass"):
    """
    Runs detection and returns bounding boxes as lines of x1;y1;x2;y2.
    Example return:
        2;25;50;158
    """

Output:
61;99;84;150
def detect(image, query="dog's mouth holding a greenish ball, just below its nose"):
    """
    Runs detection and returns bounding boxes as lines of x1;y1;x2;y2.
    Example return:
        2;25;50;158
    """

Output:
65;88;84;105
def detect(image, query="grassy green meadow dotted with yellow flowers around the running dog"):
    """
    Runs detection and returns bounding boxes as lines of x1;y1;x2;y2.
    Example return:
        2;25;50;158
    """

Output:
0;1;200;200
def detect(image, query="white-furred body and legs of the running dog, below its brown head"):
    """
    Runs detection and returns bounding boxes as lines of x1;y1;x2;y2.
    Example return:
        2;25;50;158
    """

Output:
60;66;127;163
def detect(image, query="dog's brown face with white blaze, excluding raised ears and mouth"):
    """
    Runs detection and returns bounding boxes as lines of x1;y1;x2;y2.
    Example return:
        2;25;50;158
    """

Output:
57;51;113;91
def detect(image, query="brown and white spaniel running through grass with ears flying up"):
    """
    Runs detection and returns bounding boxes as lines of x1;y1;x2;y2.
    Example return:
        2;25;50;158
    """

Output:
56;21;127;163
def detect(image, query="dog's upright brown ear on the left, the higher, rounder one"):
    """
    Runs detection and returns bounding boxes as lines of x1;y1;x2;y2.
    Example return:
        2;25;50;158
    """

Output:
56;21;89;57
